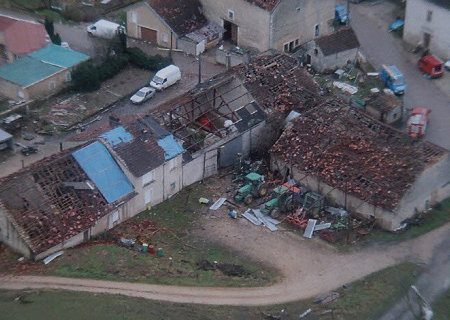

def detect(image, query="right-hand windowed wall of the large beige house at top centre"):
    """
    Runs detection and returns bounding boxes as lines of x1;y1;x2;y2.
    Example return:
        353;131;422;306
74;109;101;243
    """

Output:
271;0;336;51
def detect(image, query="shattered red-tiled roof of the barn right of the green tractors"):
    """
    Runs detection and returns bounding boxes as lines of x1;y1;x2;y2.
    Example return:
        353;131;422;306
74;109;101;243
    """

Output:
270;101;448;210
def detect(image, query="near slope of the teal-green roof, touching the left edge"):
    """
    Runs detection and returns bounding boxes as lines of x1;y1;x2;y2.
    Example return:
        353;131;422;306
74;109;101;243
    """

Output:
0;56;64;87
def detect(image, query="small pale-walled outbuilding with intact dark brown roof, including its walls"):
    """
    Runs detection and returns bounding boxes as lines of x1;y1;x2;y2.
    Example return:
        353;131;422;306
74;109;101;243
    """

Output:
301;28;360;71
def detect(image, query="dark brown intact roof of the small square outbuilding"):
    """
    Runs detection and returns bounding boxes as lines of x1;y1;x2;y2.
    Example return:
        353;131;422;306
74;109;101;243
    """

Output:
315;28;360;56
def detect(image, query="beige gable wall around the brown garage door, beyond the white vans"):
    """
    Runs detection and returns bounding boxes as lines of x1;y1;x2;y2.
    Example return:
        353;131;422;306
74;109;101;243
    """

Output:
127;2;177;49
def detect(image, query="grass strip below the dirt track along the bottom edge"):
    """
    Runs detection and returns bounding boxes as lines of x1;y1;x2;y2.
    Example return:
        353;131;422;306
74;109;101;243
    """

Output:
0;263;422;320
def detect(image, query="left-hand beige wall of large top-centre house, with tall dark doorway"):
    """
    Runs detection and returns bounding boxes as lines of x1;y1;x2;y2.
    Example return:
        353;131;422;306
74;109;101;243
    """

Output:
201;0;270;51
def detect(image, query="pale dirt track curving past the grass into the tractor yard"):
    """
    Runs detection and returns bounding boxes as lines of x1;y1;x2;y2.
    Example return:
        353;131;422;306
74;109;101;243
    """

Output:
0;217;450;306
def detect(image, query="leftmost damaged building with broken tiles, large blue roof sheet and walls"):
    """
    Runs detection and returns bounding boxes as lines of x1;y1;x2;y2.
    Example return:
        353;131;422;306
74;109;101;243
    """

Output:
0;142;135;259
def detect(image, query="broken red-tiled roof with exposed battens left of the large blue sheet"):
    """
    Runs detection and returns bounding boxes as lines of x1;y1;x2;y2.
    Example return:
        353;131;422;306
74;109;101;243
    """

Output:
0;149;134;253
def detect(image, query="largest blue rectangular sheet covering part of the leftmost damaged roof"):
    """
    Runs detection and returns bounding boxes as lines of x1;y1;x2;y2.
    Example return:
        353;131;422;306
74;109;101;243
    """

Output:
72;141;133;203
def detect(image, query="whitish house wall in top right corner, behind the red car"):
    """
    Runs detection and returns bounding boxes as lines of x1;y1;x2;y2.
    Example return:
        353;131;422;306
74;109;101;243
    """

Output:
403;0;450;59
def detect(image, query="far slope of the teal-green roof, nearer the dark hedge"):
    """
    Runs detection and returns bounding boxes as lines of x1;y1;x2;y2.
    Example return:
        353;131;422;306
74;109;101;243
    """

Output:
29;44;89;68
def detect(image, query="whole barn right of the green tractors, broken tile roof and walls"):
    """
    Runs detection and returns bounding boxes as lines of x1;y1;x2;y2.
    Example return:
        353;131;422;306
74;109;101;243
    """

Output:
270;101;450;230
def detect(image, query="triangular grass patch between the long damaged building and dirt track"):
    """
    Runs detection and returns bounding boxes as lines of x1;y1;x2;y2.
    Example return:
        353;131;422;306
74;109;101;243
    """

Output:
0;184;280;287
